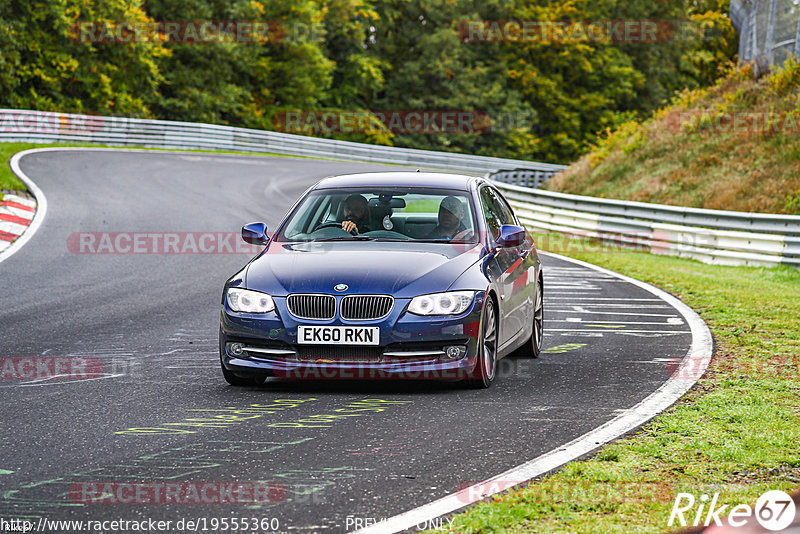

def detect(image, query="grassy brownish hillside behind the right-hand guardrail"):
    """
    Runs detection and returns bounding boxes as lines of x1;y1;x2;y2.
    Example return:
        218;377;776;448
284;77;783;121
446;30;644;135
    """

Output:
547;61;800;214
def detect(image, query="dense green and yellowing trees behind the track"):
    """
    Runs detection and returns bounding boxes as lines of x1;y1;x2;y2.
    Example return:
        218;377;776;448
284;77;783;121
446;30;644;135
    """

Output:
0;0;736;162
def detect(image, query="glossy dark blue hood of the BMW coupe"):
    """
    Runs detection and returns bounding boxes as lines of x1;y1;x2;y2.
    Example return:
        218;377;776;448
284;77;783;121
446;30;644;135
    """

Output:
246;241;481;298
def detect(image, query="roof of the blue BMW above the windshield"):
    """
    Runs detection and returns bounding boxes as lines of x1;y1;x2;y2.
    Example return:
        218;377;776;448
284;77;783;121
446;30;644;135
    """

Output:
315;171;477;191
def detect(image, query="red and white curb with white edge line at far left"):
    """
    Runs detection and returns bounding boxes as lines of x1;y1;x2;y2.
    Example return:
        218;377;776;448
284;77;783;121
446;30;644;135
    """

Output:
0;149;47;262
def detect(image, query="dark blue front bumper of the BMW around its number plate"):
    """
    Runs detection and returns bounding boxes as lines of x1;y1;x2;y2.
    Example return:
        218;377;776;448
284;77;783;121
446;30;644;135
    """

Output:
220;292;486;380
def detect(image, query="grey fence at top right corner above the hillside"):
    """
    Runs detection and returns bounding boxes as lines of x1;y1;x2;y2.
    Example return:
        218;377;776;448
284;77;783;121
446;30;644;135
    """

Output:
730;0;800;74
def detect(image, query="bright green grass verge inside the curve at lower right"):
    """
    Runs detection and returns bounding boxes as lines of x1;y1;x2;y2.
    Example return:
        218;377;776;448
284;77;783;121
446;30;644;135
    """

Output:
432;236;800;533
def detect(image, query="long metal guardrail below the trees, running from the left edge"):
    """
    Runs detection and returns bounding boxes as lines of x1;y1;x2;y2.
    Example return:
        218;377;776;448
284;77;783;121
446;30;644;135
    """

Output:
0;109;565;175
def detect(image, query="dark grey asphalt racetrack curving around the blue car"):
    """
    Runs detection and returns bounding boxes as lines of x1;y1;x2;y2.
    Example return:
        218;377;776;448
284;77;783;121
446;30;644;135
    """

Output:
0;151;691;533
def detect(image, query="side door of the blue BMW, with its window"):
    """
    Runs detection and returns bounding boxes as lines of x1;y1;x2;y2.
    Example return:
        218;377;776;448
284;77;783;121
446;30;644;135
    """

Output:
480;186;527;350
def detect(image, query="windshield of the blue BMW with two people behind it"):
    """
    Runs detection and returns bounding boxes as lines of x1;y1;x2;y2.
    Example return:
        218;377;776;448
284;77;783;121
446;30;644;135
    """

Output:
277;188;477;243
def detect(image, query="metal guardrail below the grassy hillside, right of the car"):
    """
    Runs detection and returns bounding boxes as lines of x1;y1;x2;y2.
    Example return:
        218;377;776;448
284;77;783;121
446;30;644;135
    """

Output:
486;173;800;267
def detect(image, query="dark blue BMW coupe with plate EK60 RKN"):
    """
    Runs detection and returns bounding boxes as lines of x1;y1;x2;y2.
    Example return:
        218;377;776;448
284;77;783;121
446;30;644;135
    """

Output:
219;172;544;388
